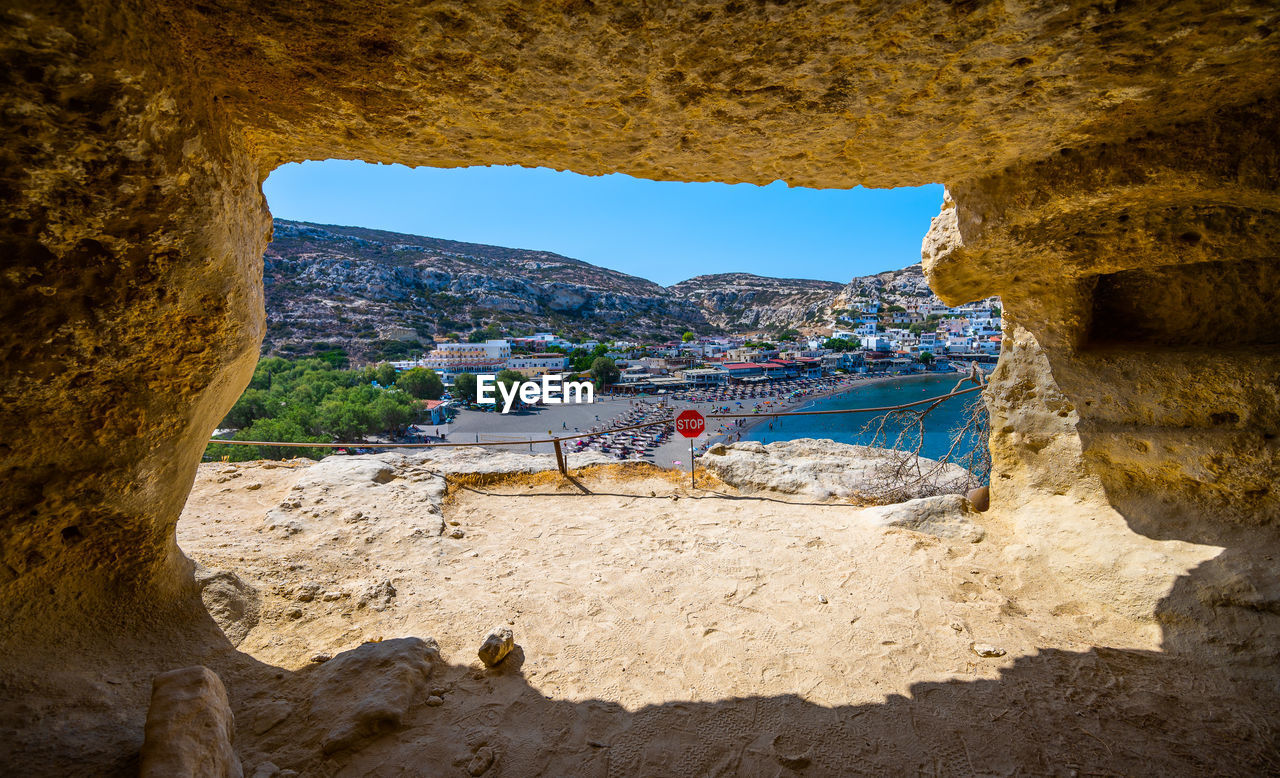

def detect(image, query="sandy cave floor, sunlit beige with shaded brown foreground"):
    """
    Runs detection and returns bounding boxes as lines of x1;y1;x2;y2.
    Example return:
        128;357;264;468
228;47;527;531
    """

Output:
170;452;1275;775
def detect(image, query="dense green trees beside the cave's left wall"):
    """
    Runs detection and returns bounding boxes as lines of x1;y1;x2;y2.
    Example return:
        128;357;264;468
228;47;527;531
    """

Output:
205;357;416;462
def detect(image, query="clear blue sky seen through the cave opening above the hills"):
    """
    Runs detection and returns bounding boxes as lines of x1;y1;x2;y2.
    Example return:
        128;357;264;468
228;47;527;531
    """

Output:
264;160;942;285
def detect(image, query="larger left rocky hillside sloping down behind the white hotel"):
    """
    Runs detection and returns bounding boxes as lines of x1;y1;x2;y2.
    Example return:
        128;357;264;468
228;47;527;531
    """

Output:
264;219;716;356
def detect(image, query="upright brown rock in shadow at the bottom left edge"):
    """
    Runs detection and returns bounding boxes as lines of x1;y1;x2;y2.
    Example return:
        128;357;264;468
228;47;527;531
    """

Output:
140;665;243;778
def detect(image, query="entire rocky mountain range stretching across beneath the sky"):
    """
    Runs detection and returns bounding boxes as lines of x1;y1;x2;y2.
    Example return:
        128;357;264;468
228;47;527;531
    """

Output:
262;219;962;360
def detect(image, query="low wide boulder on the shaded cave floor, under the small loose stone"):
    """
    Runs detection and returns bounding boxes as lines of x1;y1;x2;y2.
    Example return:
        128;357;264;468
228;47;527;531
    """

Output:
310;637;440;754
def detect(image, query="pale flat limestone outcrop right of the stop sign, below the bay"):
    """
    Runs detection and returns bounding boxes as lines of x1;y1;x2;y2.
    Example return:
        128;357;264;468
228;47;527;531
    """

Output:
698;438;970;500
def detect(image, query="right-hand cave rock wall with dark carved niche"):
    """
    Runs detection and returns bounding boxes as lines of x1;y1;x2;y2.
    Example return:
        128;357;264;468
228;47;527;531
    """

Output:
924;101;1280;536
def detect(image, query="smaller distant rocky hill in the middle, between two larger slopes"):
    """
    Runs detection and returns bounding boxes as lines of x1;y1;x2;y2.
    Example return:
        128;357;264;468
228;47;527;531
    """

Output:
669;273;844;331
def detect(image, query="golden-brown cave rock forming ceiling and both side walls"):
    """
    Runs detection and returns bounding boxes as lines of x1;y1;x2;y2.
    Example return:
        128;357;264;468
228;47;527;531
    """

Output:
0;0;1280;690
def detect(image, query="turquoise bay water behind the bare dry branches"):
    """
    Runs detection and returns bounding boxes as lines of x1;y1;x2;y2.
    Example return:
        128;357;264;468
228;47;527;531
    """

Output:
742;374;986;461
